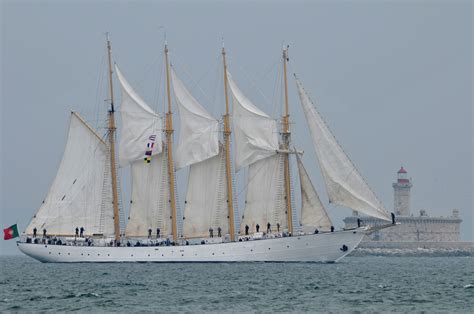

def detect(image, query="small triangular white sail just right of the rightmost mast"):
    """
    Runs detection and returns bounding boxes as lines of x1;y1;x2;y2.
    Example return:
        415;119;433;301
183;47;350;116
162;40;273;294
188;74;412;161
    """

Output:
296;155;332;232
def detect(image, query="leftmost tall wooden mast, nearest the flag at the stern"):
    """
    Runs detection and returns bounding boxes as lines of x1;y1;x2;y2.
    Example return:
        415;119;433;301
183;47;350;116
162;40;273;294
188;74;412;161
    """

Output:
107;34;120;242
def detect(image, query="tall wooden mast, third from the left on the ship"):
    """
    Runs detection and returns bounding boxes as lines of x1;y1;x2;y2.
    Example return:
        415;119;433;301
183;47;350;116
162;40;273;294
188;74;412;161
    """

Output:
222;46;235;241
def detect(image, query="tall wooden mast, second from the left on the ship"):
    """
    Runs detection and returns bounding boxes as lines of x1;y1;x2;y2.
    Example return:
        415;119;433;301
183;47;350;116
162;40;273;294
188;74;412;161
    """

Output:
165;43;178;242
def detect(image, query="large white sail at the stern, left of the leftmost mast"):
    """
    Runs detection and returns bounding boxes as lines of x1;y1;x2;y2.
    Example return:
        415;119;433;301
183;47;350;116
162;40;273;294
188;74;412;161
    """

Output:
26;112;114;236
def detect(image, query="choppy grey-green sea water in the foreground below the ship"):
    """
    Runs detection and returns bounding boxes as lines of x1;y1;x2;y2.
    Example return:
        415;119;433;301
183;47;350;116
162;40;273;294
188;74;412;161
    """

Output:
0;256;474;313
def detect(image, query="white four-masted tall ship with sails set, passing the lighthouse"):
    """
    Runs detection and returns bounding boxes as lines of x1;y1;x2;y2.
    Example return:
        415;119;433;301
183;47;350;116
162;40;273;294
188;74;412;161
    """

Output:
17;38;395;262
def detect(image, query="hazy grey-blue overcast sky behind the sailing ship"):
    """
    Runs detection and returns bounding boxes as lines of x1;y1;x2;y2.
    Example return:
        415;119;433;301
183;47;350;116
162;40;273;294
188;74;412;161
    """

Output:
0;1;474;254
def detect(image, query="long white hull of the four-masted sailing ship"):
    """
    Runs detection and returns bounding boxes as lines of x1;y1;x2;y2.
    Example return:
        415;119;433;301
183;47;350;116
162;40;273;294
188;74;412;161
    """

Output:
18;229;365;263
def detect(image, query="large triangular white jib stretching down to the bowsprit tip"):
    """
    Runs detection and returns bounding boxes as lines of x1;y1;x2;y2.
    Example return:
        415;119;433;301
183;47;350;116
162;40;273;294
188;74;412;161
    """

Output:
296;80;391;221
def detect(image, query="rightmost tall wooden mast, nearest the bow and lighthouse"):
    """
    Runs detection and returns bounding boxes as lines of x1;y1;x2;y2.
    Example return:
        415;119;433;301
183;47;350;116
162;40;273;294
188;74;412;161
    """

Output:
281;47;293;234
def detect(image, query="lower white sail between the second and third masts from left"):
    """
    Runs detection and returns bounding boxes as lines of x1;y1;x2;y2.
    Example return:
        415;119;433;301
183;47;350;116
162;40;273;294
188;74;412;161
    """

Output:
183;150;229;238
